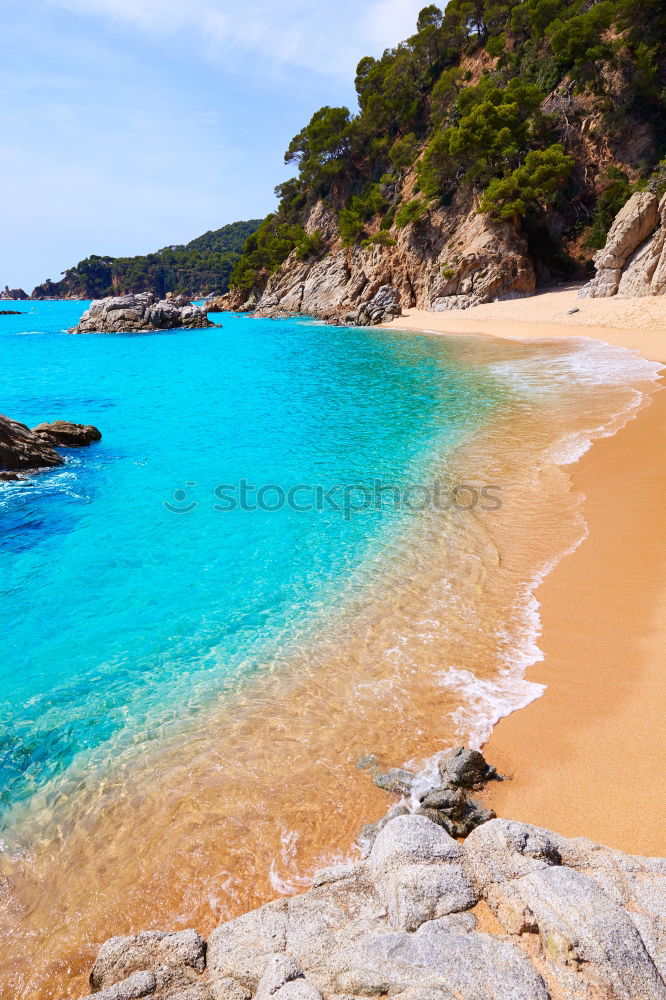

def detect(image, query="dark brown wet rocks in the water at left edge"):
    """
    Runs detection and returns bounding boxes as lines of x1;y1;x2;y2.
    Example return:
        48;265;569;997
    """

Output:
0;415;102;480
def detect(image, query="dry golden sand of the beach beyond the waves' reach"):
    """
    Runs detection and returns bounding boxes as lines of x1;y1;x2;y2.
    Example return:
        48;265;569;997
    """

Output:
382;289;666;855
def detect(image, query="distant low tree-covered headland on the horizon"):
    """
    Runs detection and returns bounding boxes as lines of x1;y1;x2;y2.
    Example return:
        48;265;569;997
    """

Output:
32;225;260;299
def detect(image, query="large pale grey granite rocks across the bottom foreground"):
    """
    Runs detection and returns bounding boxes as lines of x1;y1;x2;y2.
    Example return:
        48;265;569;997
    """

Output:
75;815;666;1000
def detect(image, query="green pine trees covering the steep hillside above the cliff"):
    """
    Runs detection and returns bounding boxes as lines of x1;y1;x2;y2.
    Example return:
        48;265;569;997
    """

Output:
231;0;666;292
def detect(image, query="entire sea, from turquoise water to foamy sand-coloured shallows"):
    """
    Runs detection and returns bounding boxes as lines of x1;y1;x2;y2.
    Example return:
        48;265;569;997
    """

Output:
0;303;654;998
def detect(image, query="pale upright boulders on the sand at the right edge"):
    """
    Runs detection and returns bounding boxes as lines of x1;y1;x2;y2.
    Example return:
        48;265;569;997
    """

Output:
579;191;666;298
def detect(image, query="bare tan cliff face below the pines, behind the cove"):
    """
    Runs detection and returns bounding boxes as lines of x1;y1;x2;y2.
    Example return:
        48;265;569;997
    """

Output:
246;201;536;325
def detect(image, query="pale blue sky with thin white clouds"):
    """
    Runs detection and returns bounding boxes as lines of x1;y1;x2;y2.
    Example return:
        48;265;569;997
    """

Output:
0;0;425;292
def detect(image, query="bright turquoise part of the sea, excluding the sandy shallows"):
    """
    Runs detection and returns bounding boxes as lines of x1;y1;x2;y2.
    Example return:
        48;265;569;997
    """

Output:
0;302;502;813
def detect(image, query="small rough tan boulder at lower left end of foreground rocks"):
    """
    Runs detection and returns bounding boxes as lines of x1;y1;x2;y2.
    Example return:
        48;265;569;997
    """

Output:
90;930;206;989
